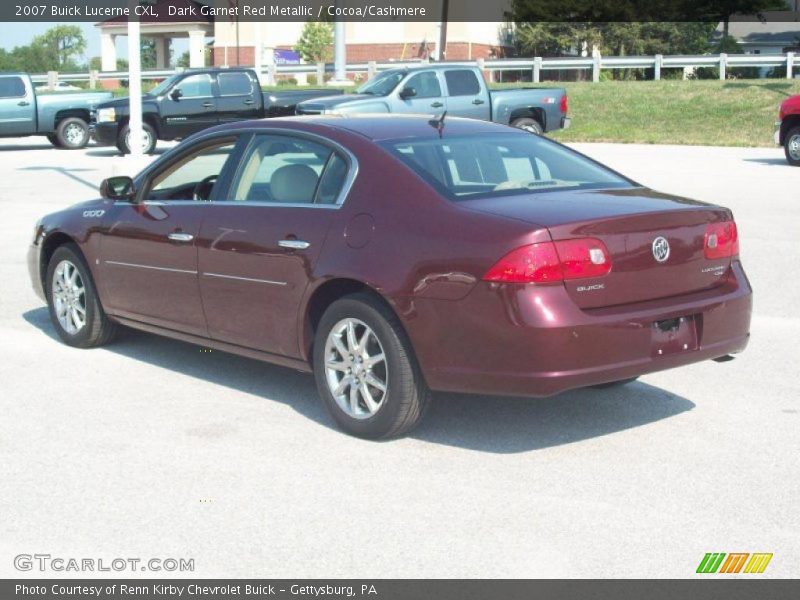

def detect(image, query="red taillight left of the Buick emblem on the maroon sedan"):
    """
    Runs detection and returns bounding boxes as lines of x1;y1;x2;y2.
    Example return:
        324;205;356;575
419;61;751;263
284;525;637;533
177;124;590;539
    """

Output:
483;238;611;284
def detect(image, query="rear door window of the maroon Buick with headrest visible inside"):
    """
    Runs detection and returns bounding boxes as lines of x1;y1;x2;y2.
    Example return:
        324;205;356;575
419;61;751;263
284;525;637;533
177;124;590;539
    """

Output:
231;135;348;204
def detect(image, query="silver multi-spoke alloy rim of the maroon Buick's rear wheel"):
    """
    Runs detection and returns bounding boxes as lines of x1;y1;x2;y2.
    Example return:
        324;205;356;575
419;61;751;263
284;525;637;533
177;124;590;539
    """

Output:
325;318;389;419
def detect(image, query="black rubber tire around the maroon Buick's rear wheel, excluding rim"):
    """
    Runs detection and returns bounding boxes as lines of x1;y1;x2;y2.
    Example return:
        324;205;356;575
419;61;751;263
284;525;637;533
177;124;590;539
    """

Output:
313;293;430;440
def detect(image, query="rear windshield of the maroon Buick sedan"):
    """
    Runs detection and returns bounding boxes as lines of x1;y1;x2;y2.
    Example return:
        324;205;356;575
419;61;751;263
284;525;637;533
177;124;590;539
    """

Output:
382;132;634;200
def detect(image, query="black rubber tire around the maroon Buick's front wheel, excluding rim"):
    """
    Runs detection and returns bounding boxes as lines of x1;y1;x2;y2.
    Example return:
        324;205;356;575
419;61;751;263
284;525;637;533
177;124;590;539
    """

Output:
45;244;117;348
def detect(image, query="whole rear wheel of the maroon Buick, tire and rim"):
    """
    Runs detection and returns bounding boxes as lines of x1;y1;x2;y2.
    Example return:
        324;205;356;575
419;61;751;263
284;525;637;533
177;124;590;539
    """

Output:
314;294;429;439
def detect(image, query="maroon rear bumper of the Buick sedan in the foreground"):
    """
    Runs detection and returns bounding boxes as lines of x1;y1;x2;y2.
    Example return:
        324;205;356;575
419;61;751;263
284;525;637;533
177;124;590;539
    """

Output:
406;261;752;396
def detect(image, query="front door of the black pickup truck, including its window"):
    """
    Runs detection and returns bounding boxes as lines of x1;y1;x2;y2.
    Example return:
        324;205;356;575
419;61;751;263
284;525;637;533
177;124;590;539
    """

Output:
161;73;218;138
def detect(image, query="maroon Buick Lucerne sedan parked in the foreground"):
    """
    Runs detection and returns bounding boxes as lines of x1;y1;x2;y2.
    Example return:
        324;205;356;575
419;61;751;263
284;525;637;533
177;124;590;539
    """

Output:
29;115;752;438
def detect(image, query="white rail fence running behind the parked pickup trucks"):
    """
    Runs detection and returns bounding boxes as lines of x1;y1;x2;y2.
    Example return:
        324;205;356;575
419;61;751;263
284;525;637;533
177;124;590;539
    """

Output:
32;52;795;87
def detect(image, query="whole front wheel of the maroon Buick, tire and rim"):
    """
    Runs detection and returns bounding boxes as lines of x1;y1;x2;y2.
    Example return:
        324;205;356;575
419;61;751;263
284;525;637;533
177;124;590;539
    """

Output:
45;244;116;348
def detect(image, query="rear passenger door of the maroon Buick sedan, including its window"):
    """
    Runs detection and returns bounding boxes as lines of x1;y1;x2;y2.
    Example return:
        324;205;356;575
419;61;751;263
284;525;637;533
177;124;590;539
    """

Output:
198;133;349;357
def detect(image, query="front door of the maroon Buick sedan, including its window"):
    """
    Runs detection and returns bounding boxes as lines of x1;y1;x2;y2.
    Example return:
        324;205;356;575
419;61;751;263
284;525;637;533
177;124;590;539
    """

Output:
100;138;239;336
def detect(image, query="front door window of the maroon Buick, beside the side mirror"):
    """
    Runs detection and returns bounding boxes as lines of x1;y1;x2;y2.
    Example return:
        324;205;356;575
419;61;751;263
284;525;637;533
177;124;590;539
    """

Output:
147;140;235;200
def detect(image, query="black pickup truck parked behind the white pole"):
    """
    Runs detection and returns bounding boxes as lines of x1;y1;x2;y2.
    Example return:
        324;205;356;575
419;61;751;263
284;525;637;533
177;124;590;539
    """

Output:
91;69;341;154
